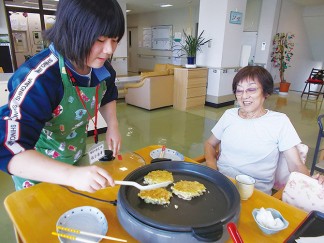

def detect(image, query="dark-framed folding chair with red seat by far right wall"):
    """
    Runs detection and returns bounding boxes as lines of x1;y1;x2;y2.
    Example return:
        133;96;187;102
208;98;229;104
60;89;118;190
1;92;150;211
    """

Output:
301;68;324;100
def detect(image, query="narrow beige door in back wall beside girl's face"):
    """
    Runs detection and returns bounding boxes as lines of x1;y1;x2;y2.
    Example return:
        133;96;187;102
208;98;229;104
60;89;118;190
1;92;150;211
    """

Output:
127;27;138;74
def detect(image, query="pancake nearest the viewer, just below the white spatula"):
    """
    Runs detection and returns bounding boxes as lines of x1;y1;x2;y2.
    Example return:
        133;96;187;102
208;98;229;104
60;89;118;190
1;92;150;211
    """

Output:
137;188;172;205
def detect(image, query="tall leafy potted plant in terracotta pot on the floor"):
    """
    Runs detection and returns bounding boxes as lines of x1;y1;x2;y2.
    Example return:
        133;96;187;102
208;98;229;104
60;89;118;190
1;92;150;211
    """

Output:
271;33;295;95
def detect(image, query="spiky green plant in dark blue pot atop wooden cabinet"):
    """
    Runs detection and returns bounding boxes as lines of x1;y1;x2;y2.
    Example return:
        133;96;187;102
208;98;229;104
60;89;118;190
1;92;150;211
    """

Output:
180;31;211;67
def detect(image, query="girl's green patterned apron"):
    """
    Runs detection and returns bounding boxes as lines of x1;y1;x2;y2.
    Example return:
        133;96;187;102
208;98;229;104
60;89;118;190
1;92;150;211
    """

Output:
12;55;106;190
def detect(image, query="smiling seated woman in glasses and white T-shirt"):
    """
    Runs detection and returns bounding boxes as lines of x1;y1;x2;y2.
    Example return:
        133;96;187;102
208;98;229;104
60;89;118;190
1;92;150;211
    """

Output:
204;66;324;194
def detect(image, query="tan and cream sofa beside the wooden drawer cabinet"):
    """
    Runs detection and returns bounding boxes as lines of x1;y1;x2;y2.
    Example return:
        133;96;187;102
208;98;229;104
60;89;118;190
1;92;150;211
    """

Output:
124;64;179;110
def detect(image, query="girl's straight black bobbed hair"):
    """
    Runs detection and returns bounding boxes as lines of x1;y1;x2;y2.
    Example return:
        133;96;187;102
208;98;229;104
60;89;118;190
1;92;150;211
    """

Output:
43;0;125;68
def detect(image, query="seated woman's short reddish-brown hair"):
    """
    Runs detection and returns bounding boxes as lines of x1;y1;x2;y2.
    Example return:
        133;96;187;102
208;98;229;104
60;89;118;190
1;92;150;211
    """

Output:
232;66;274;97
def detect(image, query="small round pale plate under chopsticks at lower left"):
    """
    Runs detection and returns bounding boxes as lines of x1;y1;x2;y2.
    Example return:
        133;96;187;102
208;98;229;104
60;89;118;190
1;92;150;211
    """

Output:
56;206;108;243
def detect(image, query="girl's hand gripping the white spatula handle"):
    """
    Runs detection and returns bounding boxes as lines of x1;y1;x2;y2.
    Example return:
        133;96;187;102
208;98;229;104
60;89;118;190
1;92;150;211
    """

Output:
67;165;115;192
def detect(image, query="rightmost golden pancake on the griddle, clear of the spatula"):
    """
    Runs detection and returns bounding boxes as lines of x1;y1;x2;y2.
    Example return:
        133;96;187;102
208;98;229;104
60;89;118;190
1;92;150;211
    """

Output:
171;181;206;200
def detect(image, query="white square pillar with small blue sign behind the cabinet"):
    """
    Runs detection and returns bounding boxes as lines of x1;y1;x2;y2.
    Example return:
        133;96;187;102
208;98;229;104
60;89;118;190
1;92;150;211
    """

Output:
197;0;246;107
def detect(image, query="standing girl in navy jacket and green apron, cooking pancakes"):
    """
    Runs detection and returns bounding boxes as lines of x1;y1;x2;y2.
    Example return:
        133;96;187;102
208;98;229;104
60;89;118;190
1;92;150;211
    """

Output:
0;0;125;192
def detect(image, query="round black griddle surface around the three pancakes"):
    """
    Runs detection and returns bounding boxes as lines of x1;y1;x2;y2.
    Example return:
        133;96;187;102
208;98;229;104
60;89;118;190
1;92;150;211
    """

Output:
118;161;240;232
